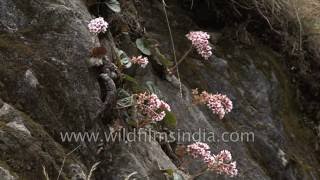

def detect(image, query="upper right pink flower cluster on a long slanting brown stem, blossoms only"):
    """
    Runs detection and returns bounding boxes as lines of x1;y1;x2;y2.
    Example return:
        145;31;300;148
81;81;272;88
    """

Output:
186;31;212;60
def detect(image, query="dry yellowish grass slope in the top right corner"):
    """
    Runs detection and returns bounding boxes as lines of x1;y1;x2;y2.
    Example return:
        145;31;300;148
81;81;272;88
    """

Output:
230;0;320;53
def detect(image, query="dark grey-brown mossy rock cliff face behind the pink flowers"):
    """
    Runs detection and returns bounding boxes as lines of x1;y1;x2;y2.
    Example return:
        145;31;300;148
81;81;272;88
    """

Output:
0;0;320;180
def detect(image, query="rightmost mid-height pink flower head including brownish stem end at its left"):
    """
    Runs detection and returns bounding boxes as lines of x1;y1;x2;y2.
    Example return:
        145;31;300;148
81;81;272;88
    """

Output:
192;89;233;119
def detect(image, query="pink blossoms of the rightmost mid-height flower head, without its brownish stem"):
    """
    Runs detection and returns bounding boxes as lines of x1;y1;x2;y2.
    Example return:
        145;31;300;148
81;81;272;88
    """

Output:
200;91;233;119
